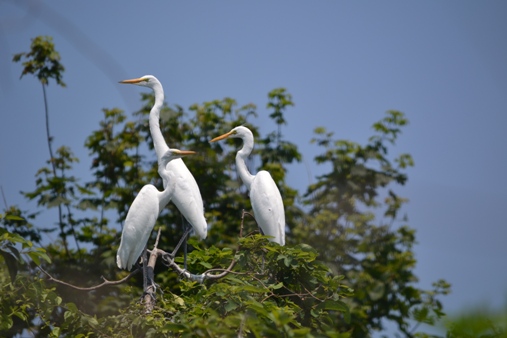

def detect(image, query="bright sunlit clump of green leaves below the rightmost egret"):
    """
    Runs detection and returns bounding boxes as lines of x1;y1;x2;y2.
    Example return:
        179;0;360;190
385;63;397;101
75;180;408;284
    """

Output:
80;236;350;337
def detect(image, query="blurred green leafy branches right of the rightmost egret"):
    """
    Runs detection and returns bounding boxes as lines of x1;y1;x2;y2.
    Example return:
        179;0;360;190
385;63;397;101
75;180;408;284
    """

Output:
294;111;450;337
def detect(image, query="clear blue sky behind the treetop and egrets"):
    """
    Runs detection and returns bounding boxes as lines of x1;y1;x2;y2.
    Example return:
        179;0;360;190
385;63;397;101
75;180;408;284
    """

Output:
0;0;507;324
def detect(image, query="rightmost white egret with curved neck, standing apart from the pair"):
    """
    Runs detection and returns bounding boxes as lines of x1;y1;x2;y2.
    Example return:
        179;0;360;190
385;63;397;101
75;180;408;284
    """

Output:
210;126;285;245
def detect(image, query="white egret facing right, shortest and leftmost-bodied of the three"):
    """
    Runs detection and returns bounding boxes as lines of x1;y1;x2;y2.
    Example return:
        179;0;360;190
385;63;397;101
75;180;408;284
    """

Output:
116;149;195;270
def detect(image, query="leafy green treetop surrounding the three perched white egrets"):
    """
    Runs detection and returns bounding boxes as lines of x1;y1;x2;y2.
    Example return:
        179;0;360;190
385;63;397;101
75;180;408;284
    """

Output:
0;35;449;337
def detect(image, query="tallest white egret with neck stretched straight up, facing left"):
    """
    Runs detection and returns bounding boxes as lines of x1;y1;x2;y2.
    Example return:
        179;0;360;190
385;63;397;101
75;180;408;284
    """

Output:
120;75;208;270
